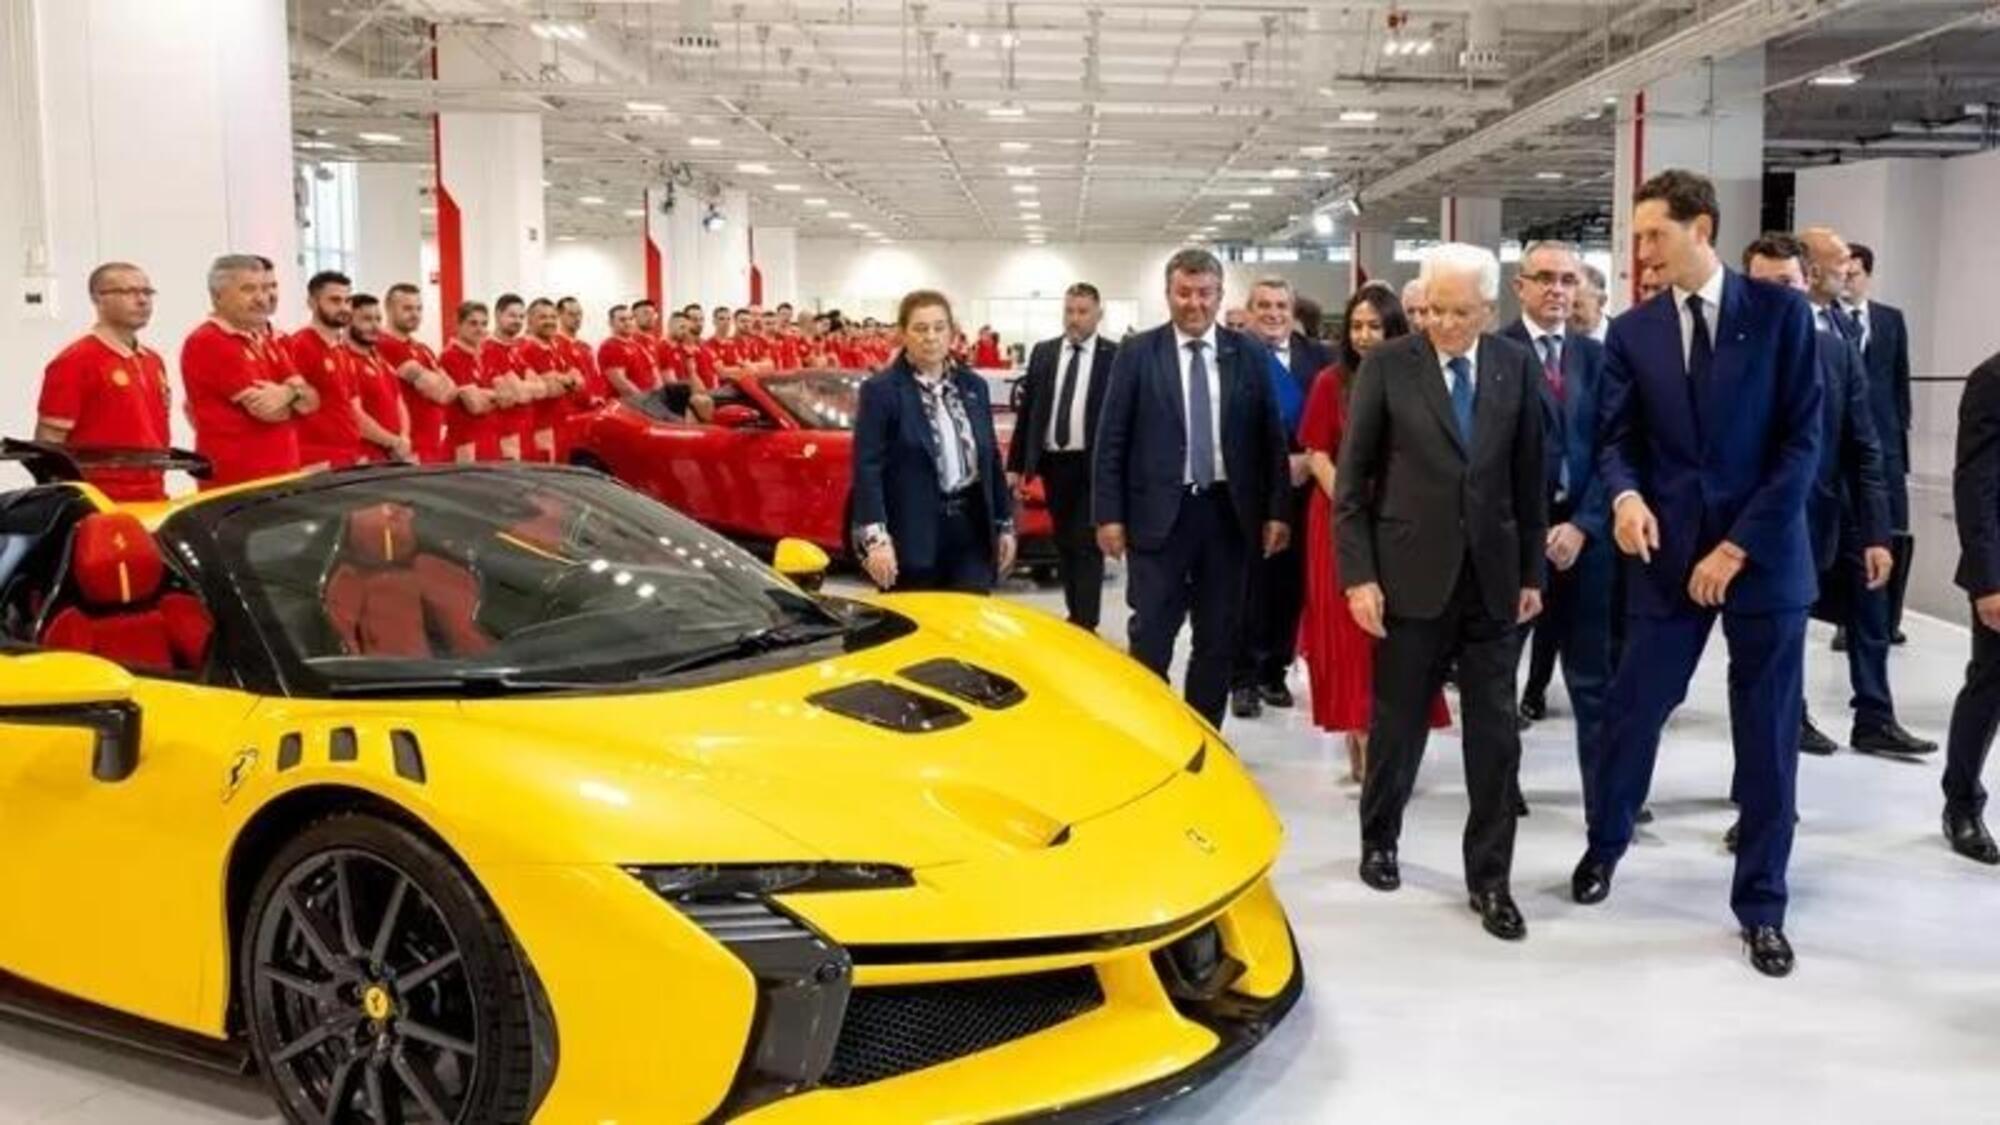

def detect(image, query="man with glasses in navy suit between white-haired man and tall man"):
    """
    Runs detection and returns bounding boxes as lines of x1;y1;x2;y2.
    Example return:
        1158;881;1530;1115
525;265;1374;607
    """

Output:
1500;242;1616;776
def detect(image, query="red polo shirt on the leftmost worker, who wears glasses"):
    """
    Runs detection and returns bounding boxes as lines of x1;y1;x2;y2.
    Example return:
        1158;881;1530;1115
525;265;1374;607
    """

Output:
36;332;172;494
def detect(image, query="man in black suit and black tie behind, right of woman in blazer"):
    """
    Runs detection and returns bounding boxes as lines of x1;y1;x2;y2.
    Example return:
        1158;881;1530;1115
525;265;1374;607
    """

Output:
1006;282;1118;633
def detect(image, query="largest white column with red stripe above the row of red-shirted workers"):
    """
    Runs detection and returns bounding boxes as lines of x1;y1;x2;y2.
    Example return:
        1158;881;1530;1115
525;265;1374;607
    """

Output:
436;28;548;336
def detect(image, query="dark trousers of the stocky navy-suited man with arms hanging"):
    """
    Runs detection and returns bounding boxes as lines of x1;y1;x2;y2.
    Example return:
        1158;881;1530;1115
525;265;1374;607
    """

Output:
1126;484;1250;729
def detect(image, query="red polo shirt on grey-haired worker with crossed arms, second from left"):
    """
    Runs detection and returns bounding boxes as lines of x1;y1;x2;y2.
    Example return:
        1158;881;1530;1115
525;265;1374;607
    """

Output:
180;318;300;488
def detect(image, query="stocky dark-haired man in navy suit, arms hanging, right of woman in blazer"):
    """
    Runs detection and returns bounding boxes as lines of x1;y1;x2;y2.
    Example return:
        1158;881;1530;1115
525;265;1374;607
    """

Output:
1090;248;1292;727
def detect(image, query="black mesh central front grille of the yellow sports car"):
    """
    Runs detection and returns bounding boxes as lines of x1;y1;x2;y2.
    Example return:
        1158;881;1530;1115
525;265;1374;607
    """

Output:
820;969;1104;1087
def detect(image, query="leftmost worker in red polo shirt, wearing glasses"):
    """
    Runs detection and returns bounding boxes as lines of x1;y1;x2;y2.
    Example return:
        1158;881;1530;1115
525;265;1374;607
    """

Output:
34;262;172;502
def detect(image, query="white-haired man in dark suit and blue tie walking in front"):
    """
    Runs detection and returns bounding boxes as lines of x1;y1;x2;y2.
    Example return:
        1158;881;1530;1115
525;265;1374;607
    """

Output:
1334;242;1548;941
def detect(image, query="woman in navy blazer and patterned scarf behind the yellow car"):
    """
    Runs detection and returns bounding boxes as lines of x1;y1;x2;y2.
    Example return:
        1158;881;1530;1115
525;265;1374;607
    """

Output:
852;290;1014;593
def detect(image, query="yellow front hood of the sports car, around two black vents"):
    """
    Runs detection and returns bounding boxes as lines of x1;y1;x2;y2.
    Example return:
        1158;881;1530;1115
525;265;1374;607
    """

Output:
460;595;1206;867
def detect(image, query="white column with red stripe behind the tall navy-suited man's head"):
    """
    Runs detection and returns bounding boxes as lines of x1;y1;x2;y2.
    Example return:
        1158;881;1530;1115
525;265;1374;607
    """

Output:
1610;46;1764;312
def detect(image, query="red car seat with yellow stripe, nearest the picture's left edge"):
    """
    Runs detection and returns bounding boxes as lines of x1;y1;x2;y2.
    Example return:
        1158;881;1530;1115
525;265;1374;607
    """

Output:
42;512;214;673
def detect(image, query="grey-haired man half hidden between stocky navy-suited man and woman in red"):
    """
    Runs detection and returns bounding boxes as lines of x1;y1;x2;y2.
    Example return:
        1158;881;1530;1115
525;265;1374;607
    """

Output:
1230;276;1334;719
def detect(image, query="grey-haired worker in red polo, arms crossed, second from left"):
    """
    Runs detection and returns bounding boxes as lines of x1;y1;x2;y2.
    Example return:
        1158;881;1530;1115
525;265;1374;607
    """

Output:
180;254;320;488
